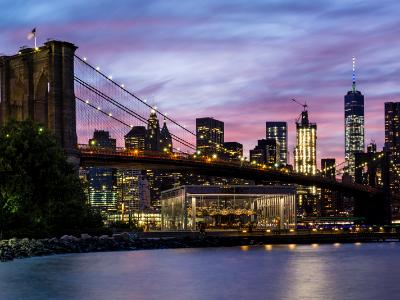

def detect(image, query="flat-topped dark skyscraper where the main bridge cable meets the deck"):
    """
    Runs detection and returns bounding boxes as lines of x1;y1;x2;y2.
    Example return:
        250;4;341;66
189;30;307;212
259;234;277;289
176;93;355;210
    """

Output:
196;118;224;155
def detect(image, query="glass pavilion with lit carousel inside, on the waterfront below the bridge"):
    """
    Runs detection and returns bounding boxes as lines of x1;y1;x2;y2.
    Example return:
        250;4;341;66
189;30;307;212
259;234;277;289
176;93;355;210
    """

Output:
161;185;296;230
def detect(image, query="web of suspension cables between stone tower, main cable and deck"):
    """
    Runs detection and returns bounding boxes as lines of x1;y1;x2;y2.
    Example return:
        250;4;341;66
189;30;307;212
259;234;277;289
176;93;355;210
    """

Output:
74;56;196;152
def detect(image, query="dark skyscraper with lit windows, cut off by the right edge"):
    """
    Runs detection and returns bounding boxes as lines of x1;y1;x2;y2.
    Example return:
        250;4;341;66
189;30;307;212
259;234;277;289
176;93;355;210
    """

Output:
385;102;400;193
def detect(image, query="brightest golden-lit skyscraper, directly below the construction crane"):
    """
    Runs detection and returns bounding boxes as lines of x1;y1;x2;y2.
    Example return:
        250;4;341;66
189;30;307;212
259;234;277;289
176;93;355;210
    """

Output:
294;108;317;175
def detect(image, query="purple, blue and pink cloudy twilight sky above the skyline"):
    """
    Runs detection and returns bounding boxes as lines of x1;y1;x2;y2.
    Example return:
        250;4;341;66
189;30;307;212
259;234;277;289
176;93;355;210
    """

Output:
0;0;400;161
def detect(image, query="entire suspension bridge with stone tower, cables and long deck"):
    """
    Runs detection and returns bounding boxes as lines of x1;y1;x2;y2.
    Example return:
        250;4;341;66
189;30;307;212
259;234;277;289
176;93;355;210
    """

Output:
0;41;391;224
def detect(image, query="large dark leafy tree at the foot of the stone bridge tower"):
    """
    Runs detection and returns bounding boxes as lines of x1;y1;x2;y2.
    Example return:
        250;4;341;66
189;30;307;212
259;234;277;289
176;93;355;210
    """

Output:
0;120;101;236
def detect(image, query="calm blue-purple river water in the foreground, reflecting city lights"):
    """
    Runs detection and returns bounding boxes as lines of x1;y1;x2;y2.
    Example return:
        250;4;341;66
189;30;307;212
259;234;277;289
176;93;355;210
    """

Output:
0;243;400;300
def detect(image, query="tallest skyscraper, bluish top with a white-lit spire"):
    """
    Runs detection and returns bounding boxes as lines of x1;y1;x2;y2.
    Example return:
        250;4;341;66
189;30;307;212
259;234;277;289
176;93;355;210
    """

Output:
344;57;365;176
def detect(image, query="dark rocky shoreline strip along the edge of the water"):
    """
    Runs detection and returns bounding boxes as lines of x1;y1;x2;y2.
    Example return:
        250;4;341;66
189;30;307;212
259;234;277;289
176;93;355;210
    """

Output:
0;232;400;262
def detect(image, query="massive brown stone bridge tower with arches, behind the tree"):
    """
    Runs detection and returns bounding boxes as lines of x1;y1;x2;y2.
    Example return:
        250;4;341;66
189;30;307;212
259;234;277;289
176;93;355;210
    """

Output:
0;41;78;164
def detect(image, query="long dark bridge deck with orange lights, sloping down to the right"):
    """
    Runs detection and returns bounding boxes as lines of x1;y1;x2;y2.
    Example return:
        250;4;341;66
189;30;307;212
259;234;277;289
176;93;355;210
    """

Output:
79;145;383;196
